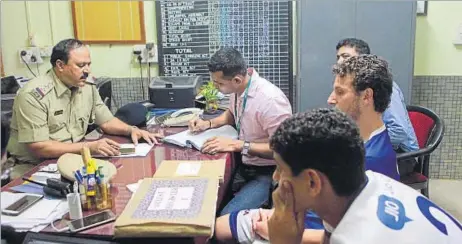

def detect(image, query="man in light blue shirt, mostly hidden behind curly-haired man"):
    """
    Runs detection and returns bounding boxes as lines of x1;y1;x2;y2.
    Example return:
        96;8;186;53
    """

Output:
335;38;419;176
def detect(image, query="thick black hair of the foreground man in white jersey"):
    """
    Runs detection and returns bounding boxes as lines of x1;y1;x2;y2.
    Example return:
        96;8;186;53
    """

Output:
270;108;365;196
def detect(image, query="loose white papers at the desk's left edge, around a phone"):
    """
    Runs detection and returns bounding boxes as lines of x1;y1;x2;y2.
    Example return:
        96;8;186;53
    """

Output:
0;192;69;232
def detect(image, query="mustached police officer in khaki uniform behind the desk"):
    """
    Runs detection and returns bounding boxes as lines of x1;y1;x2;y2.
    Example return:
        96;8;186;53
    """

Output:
7;39;160;179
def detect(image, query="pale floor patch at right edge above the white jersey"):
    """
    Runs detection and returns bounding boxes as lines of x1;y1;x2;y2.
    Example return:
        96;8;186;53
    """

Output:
429;179;462;221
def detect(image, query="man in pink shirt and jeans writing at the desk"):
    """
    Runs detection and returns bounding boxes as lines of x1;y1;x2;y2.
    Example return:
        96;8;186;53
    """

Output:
189;47;292;215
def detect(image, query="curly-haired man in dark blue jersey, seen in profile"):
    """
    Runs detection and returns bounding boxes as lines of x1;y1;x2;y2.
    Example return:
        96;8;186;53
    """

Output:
216;55;399;243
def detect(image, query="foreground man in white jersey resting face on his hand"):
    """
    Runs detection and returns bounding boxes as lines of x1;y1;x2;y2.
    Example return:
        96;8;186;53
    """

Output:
216;109;462;244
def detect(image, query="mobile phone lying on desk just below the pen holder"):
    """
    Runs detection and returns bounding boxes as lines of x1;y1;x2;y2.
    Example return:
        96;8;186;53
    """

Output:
67;210;116;232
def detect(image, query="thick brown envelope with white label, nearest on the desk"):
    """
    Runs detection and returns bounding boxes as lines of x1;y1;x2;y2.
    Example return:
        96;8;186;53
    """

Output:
114;177;218;238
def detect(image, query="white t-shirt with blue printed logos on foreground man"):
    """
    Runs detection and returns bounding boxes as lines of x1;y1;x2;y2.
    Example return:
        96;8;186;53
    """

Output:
325;171;462;244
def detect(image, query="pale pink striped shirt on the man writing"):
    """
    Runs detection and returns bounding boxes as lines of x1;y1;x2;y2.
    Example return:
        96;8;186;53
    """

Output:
229;69;292;166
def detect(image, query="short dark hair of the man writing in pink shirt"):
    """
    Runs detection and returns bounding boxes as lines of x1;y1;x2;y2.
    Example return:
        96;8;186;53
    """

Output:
208;47;247;78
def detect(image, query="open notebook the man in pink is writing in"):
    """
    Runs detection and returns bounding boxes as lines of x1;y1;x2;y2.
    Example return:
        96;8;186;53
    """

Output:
163;125;237;150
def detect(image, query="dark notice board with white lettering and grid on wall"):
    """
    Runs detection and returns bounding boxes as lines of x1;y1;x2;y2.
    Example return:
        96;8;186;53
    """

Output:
156;0;293;102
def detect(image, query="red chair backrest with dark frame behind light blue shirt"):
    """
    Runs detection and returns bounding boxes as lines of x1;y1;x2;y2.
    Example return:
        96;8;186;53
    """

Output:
407;105;444;151
